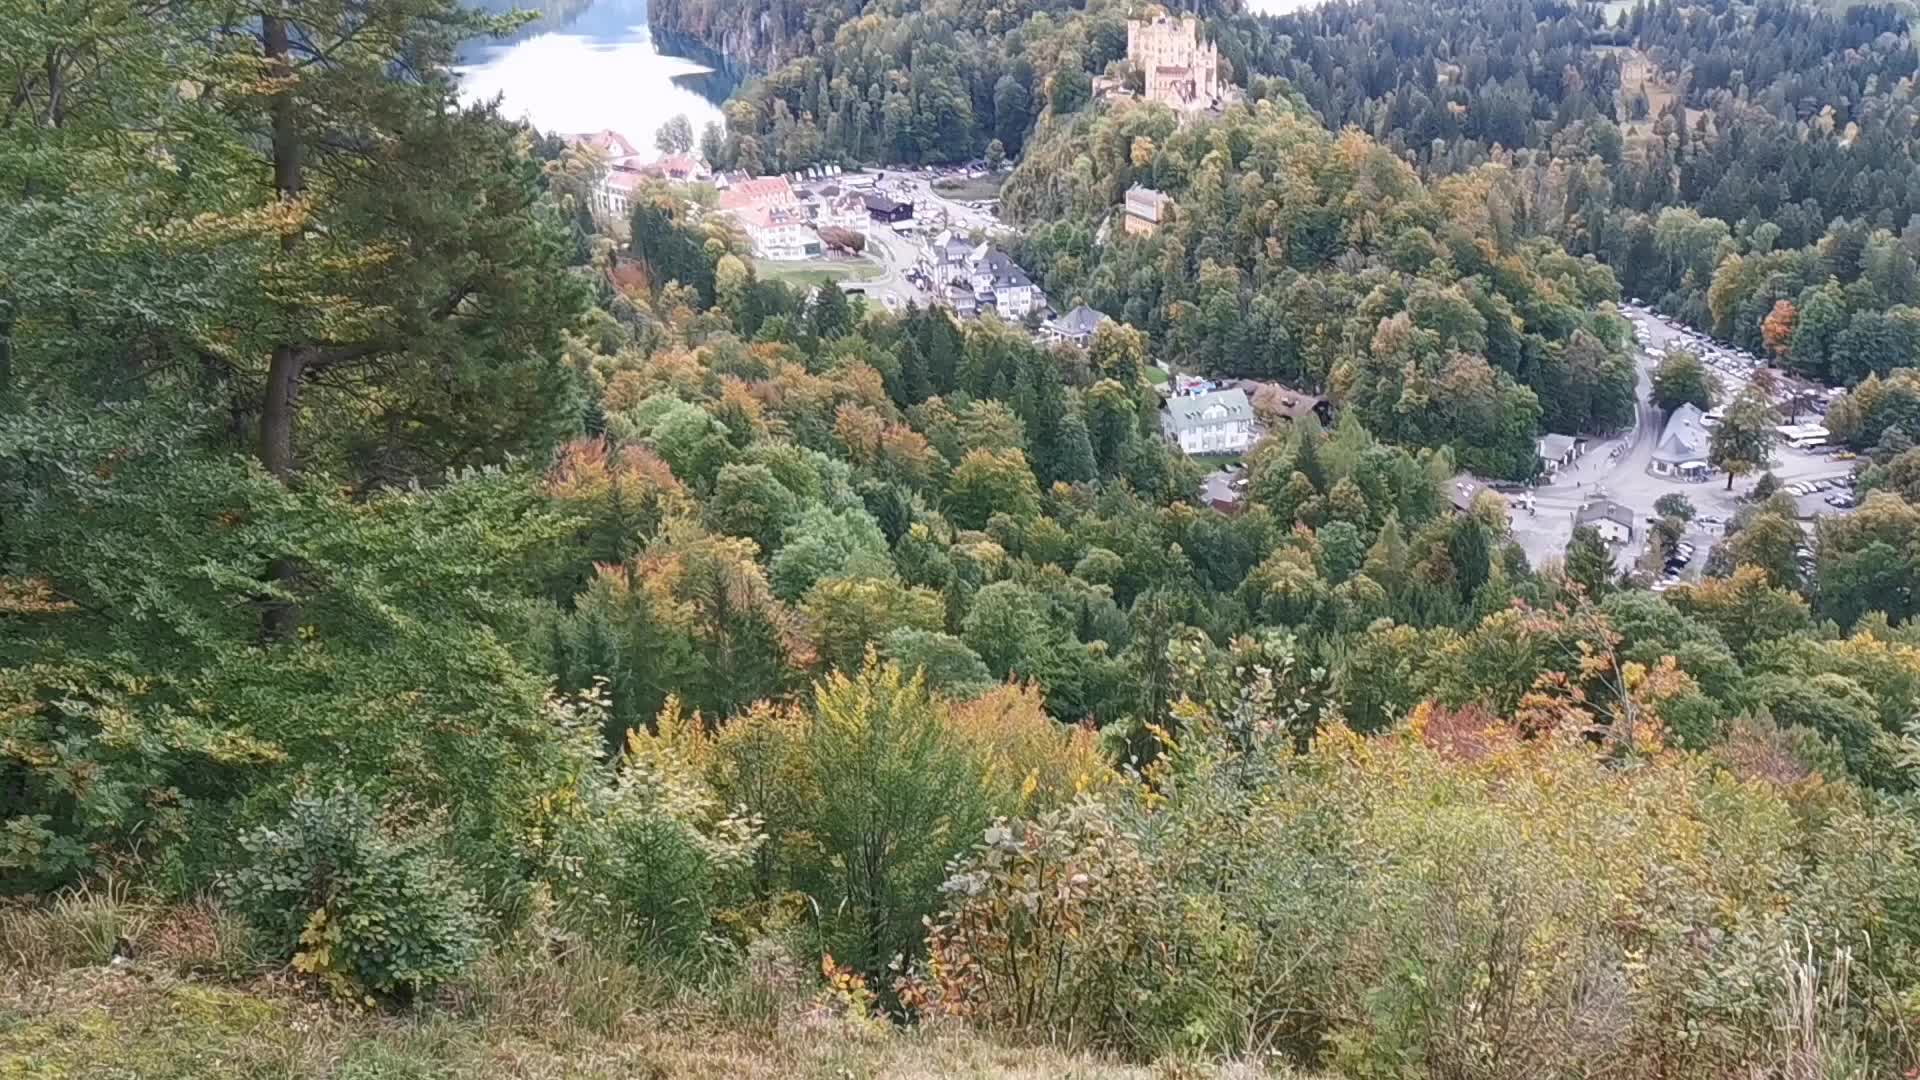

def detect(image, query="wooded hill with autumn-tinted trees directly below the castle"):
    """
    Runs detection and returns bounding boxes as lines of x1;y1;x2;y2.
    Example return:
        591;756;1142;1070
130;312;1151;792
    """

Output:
1002;100;1634;470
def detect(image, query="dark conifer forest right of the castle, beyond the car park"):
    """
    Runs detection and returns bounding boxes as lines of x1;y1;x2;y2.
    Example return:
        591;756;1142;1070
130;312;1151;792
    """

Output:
1221;0;1920;384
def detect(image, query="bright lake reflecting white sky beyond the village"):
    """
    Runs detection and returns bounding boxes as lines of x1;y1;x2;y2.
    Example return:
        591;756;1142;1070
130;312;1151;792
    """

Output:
459;0;735;154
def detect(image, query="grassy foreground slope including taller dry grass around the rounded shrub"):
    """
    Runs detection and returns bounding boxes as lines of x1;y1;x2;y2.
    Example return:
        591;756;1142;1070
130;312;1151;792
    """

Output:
0;892;1228;1080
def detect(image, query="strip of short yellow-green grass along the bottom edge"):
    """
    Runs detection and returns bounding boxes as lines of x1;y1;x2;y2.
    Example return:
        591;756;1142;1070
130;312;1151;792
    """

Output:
0;965;1156;1080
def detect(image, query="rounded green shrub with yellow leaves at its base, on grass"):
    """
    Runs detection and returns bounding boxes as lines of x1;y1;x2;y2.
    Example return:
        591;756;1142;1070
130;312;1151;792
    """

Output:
225;788;480;1001
